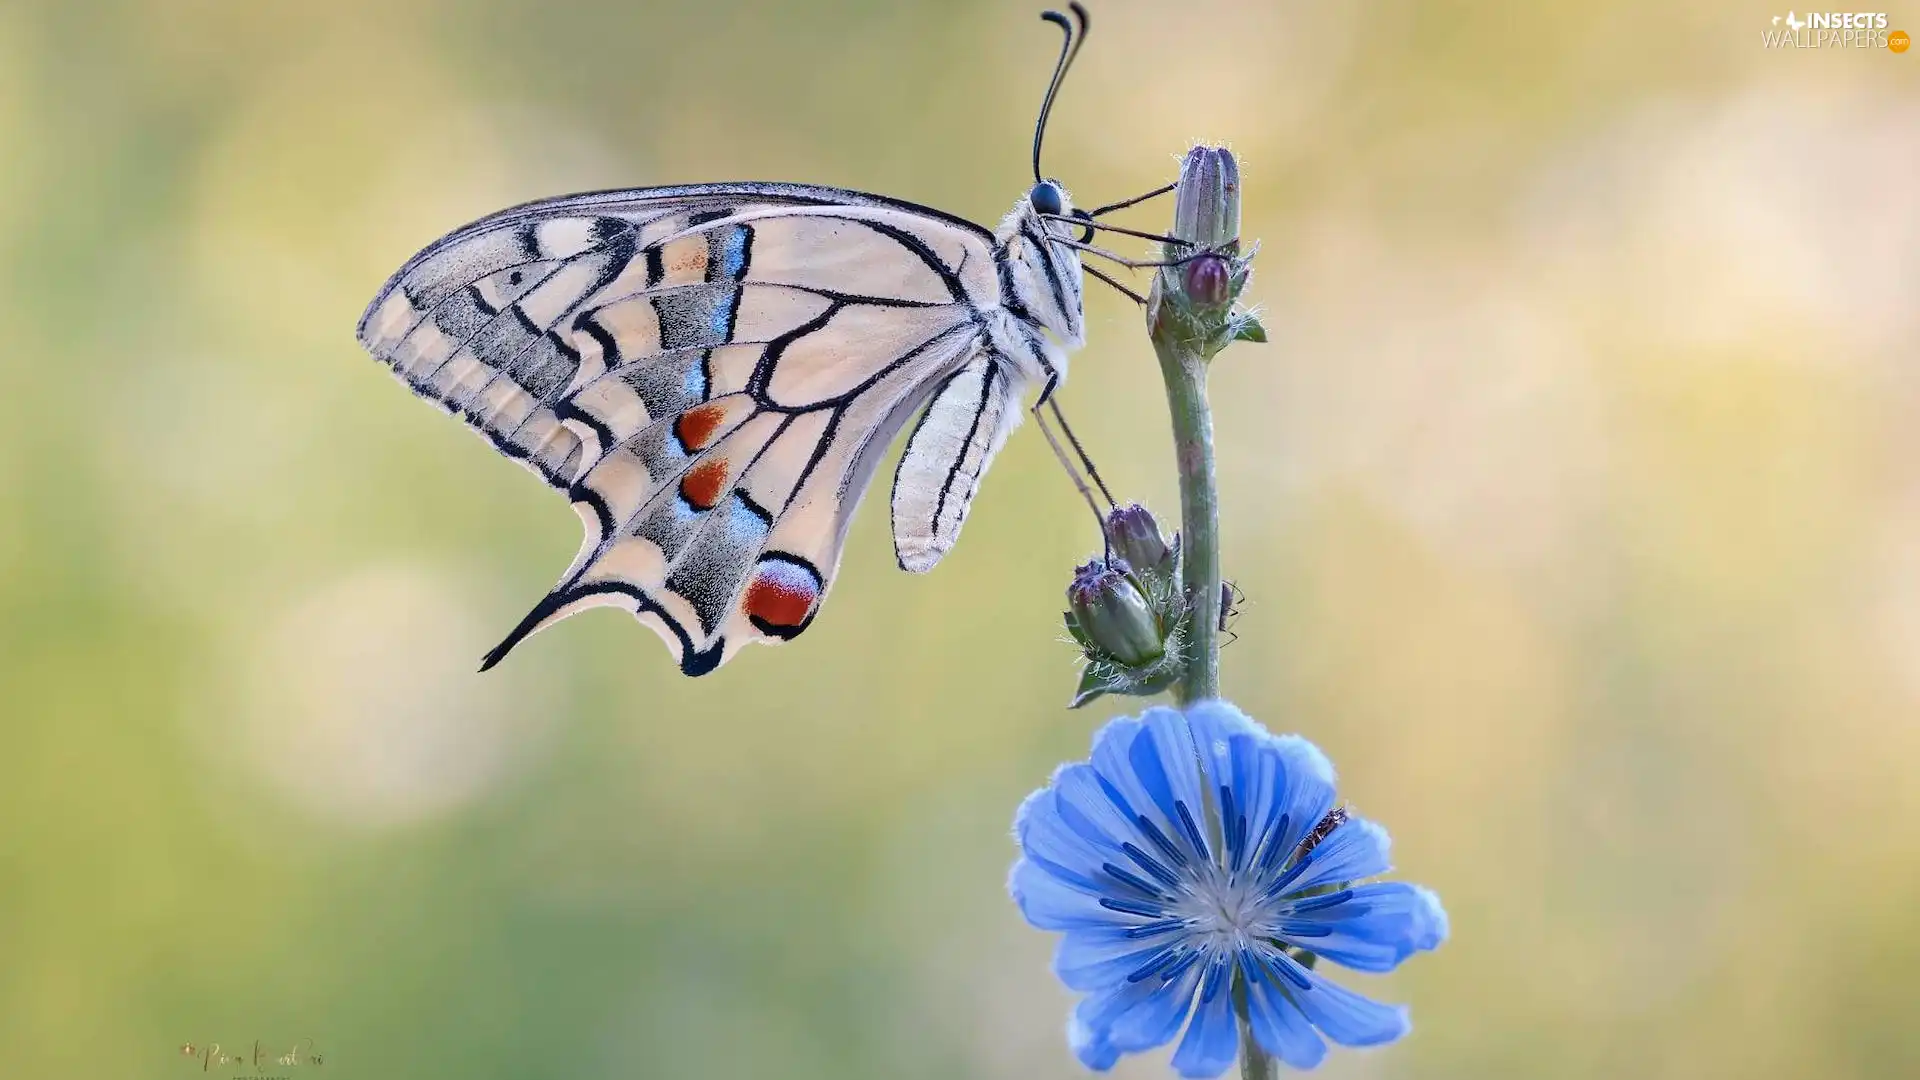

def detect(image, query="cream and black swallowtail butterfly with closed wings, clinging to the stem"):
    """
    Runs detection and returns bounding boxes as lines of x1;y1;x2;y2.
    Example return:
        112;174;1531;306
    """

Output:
359;4;1171;675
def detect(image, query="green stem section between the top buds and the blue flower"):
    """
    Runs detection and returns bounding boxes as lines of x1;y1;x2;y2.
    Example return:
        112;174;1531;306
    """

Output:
1152;323;1219;705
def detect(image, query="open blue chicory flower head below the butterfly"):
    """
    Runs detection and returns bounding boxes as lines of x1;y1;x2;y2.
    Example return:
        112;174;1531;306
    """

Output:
1008;701;1448;1078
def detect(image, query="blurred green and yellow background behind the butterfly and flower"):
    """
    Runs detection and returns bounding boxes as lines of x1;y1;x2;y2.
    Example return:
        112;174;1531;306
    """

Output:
0;0;1920;1080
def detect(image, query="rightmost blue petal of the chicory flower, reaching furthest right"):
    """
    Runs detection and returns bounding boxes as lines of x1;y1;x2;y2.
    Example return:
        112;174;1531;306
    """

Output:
1275;882;1448;972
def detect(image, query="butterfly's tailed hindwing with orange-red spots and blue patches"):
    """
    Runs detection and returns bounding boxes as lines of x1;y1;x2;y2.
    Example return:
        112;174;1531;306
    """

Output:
490;329;975;675
